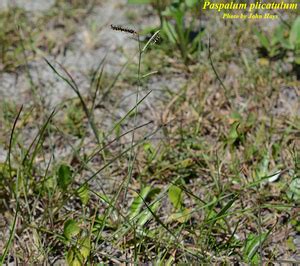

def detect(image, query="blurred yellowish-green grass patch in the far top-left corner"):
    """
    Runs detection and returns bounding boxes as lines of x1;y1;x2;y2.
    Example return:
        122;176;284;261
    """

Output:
0;0;100;72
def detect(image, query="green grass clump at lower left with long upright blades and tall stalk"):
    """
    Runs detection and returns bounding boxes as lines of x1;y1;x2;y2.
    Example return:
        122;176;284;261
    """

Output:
1;17;164;264
